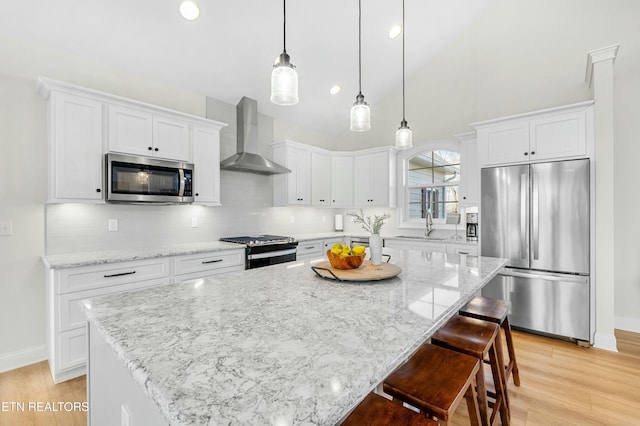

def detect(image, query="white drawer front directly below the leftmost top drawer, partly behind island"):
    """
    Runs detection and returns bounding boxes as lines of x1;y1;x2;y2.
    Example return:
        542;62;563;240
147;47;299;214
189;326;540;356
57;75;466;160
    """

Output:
58;278;170;331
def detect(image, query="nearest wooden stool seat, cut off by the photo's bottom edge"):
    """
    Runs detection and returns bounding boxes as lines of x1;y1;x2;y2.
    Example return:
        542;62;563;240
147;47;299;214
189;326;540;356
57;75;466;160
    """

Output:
341;393;438;426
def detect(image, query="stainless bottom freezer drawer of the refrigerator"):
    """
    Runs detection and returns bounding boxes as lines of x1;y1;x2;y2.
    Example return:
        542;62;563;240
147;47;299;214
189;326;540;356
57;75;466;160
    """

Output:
482;268;590;341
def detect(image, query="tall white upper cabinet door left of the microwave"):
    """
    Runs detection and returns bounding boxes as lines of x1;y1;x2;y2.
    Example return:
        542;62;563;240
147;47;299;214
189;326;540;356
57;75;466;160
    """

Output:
49;92;104;203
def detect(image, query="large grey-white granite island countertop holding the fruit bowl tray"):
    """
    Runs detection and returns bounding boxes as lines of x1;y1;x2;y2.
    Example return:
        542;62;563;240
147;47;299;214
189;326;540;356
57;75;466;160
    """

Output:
83;249;506;425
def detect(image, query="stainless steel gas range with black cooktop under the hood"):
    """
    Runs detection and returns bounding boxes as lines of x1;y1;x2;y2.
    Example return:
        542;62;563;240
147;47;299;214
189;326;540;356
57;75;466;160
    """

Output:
220;235;298;269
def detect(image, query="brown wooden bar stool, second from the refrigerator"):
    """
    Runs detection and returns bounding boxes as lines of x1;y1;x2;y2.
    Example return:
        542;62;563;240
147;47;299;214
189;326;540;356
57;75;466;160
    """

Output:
431;315;510;426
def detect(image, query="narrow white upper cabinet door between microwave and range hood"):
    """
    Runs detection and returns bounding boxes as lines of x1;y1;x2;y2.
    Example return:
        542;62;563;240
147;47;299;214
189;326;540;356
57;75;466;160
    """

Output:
192;126;220;206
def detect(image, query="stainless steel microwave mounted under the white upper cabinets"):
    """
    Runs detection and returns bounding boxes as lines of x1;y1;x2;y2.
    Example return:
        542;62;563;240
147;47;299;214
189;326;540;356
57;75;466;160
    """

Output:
105;153;193;204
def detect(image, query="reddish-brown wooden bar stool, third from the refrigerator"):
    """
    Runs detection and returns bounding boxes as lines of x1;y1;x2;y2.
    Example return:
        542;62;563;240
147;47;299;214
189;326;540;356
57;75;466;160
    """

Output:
382;344;481;426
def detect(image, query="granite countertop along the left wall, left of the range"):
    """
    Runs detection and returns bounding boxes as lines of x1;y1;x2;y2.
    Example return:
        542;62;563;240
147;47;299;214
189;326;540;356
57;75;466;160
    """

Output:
42;241;245;269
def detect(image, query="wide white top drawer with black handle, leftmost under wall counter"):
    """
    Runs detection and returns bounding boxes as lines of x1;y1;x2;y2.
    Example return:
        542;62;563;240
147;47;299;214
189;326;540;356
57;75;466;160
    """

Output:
56;258;170;294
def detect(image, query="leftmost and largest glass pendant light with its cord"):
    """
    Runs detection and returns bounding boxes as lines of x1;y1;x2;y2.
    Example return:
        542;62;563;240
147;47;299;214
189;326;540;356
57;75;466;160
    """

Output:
271;0;298;105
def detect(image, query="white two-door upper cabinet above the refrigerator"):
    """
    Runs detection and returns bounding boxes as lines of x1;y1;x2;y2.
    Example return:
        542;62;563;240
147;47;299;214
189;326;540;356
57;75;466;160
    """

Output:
473;101;593;167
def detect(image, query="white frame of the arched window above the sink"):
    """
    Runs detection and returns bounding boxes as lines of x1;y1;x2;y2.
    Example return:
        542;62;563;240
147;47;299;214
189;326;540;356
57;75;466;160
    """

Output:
397;140;464;229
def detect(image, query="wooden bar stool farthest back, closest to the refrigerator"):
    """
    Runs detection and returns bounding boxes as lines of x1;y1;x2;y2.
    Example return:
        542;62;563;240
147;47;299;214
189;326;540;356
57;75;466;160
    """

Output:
459;297;520;386
